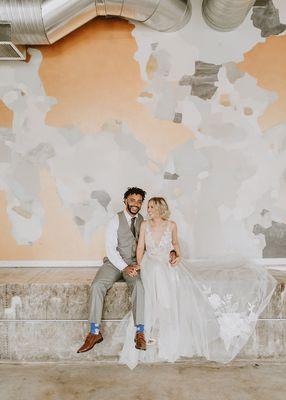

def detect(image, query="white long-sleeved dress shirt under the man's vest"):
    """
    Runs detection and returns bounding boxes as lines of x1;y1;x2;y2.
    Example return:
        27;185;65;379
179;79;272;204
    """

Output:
105;210;138;271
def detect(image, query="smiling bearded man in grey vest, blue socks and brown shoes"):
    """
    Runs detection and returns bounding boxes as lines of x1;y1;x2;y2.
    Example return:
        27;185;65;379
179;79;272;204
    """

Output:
77;187;146;353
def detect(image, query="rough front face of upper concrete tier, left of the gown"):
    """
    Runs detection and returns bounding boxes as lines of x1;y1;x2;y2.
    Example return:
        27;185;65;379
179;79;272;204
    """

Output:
0;282;130;320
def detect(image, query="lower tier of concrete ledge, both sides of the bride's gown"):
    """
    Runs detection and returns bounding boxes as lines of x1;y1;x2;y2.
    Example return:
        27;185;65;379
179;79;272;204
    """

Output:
0;320;286;361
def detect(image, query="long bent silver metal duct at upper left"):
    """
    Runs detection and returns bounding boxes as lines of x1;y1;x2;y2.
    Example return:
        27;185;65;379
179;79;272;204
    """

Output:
0;0;191;44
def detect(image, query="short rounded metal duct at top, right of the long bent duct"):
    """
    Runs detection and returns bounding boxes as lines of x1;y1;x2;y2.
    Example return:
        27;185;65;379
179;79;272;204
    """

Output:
202;0;256;31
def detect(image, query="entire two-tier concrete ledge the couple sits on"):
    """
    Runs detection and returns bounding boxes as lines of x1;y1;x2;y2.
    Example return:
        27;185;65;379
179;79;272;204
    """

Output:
0;268;286;361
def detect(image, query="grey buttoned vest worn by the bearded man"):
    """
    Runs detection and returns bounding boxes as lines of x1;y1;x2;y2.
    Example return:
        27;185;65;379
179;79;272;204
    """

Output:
103;211;144;265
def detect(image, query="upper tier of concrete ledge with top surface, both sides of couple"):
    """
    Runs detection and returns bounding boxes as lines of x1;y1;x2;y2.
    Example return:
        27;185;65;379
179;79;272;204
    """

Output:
0;268;286;320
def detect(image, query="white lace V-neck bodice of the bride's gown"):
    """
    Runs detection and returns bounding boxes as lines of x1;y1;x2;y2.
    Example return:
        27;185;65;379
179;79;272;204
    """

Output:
145;220;173;258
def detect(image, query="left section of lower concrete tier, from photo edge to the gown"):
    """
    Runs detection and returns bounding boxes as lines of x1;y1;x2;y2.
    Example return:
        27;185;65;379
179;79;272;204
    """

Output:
0;321;120;361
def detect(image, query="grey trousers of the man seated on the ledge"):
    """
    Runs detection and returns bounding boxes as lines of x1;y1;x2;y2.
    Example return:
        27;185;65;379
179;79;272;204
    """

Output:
89;262;144;325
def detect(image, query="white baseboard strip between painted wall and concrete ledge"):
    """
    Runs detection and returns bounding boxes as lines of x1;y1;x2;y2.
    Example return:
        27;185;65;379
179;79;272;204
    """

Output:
0;258;286;270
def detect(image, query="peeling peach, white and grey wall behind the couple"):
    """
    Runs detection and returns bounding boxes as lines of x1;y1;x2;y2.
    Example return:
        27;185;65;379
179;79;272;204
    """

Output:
0;0;286;260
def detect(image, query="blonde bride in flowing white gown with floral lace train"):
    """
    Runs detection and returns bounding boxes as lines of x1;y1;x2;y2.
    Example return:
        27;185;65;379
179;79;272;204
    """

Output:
117;197;276;368
